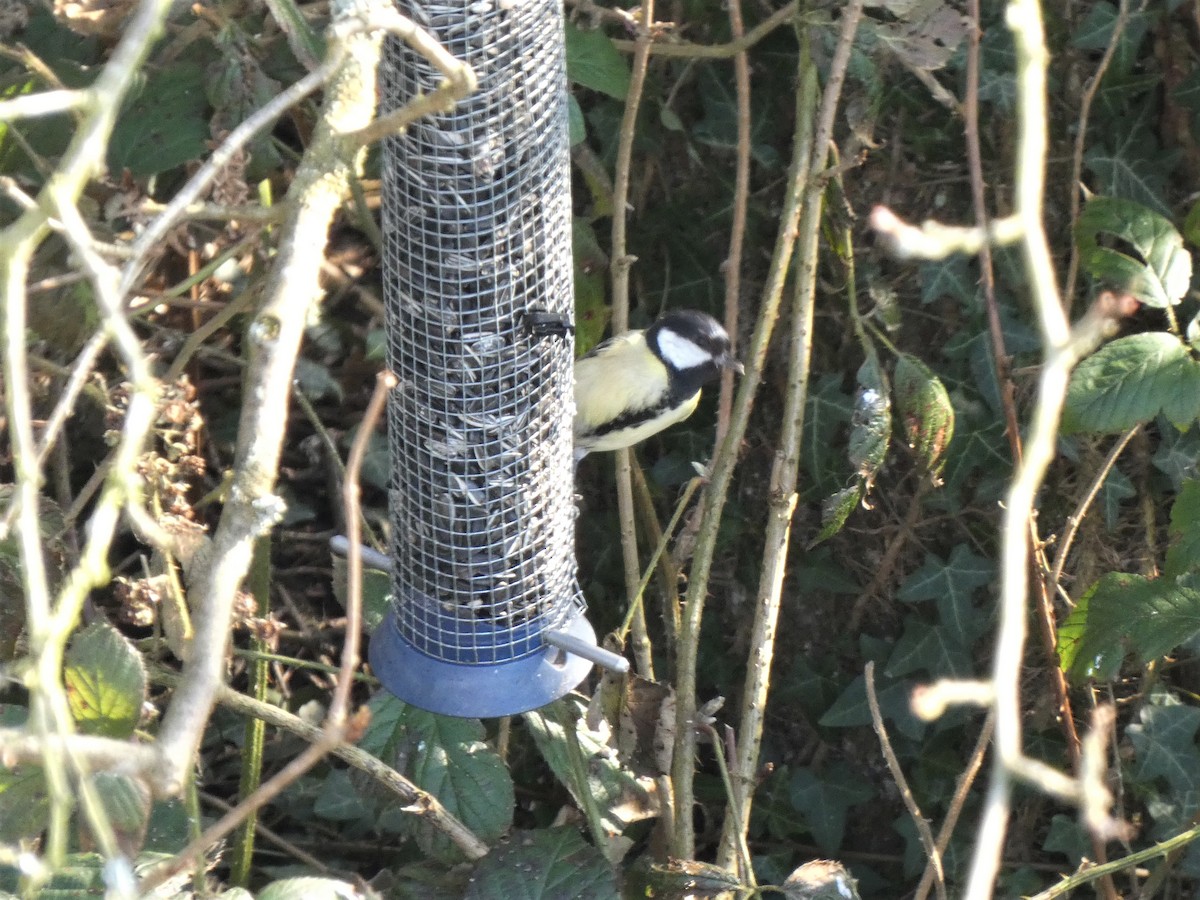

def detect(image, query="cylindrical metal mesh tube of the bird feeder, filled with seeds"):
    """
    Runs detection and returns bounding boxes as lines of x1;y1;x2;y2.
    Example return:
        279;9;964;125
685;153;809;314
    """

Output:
382;0;582;664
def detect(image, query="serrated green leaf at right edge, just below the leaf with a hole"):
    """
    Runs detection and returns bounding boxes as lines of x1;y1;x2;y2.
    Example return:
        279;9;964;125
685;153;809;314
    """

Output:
1062;331;1200;434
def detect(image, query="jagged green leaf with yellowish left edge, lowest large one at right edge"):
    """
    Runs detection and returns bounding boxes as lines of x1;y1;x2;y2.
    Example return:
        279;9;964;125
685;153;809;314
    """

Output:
1058;572;1200;682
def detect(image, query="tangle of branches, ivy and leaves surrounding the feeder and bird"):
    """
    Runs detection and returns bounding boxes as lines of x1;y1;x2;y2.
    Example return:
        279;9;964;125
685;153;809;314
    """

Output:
7;0;1200;900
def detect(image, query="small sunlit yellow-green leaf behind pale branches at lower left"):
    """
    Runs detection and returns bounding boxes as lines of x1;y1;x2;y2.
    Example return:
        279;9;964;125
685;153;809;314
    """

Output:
62;623;146;738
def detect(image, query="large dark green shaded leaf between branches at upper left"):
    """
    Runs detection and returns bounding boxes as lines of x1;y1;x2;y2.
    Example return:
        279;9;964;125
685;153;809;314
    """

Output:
108;62;212;176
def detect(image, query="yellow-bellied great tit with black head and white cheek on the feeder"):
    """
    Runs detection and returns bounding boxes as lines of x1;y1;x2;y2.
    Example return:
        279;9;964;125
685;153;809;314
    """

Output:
575;310;743;463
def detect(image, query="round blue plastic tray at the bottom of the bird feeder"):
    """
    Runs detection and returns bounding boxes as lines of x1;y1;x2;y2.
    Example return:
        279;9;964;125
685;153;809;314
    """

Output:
368;610;596;719
